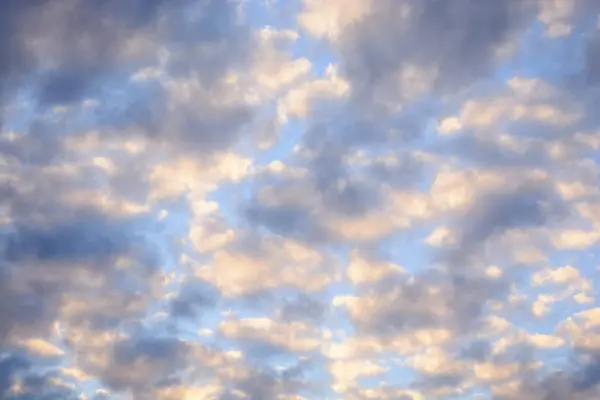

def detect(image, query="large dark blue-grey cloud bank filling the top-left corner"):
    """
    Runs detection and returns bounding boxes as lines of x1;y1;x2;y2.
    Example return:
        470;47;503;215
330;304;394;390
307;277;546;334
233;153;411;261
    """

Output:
0;0;256;160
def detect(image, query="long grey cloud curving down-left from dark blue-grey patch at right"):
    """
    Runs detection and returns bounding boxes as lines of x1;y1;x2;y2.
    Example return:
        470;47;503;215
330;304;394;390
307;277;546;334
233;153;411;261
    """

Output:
340;183;565;337
